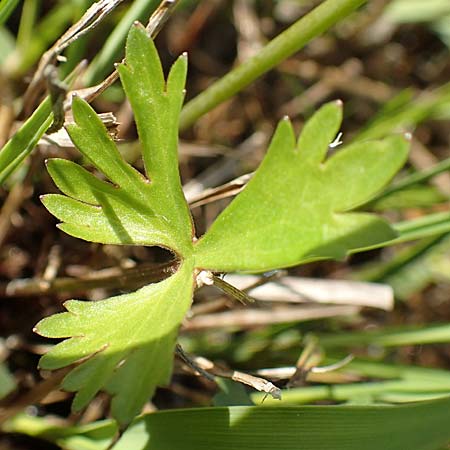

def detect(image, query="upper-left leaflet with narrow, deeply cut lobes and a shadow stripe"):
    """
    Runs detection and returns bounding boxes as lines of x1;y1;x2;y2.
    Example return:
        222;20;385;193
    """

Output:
43;26;194;256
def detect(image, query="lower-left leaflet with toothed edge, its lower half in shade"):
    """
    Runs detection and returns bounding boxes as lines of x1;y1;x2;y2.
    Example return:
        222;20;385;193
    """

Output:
35;261;194;424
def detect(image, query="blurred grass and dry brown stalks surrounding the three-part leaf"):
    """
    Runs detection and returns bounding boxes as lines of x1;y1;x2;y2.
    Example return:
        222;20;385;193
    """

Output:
0;0;450;450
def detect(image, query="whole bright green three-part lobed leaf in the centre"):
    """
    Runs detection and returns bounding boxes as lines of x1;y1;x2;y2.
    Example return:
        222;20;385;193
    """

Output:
36;25;408;425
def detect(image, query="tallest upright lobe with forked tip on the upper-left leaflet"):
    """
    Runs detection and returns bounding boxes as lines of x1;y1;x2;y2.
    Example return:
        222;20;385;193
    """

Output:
118;24;193;246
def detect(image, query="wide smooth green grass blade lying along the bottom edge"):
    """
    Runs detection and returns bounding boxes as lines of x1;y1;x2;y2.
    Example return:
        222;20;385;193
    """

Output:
113;397;450;450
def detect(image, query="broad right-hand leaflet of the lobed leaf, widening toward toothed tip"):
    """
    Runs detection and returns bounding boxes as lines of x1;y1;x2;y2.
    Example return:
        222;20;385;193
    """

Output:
195;102;409;272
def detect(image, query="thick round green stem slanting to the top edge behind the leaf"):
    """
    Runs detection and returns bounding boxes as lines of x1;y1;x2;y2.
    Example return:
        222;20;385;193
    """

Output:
180;0;367;130
